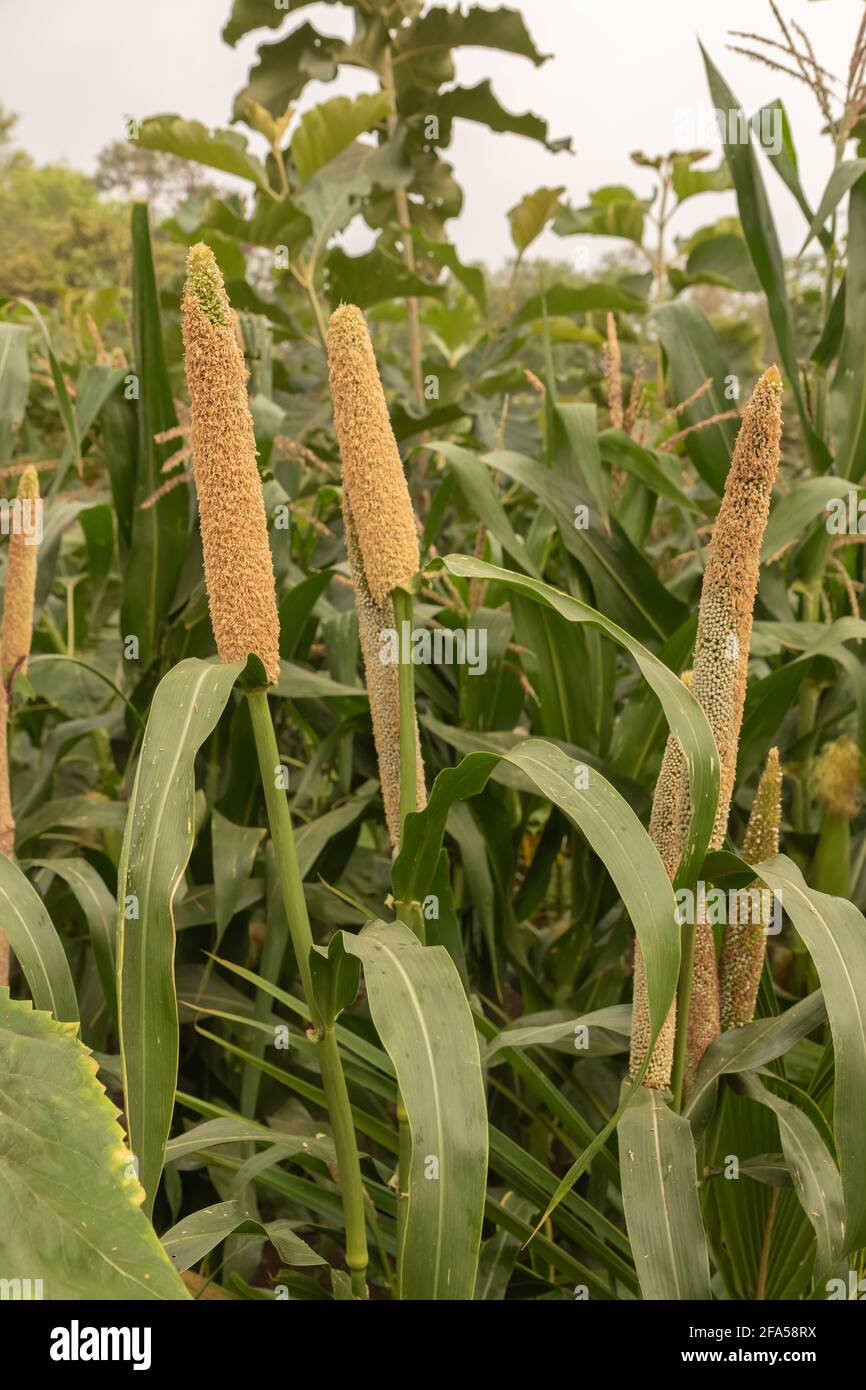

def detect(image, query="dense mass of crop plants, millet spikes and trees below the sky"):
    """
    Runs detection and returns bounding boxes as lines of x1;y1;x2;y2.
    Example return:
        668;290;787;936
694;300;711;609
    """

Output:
0;0;866;1300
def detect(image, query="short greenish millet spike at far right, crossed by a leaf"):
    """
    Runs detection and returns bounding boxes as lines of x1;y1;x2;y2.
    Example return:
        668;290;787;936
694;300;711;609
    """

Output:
719;748;781;1029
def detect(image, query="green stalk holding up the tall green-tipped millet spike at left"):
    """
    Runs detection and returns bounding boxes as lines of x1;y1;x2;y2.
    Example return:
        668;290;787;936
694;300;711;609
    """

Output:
249;689;367;1298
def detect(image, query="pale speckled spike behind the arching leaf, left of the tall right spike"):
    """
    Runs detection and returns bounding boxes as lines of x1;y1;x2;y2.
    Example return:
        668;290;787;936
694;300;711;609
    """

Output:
628;671;691;1091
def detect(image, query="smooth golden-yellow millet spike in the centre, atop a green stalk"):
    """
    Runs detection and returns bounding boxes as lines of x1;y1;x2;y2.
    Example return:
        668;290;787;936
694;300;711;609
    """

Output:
327;304;421;603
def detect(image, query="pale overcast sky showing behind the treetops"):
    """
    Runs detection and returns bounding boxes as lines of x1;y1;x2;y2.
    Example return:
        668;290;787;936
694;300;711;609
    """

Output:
0;0;863;264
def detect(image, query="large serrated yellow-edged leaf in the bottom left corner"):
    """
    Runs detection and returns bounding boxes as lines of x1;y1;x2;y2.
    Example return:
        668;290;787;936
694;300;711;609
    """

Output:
0;990;189;1301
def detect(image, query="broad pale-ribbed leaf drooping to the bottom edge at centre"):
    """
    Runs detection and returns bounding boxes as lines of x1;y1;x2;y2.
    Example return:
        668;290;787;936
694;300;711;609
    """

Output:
342;922;488;1300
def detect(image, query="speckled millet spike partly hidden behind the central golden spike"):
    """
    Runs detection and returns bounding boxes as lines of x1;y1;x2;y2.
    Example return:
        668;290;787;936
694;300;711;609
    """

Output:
343;492;427;849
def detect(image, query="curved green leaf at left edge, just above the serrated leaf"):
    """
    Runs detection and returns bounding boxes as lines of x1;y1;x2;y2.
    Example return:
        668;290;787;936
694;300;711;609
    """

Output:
0;855;78;1023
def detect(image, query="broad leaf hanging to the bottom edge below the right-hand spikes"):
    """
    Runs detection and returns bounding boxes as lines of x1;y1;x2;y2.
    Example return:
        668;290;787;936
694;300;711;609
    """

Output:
619;1087;712;1301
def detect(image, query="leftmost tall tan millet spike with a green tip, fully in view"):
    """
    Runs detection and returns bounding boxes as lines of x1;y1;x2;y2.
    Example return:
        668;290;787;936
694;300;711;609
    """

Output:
182;243;279;681
